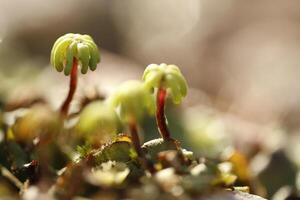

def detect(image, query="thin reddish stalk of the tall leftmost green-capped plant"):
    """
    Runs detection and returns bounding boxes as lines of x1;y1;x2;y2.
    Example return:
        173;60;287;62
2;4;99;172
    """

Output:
60;58;78;116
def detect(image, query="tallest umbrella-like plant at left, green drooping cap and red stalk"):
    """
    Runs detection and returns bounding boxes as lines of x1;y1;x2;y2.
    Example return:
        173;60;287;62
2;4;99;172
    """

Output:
50;33;100;116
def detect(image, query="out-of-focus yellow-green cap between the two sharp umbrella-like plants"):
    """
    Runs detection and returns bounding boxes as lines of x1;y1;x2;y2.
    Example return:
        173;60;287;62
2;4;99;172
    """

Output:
110;80;155;123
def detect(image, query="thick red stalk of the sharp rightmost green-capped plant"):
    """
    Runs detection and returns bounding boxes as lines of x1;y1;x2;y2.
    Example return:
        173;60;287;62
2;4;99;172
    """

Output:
156;88;171;140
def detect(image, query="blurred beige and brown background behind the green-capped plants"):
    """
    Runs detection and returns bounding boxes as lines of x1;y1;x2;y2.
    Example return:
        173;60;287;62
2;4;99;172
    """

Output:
0;0;300;198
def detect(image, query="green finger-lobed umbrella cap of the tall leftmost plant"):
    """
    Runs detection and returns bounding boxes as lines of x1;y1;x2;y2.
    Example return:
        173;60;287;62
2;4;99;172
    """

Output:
50;33;100;76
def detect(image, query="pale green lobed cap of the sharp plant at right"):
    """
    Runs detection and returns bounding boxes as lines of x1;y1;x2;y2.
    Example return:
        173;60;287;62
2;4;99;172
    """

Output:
143;63;188;104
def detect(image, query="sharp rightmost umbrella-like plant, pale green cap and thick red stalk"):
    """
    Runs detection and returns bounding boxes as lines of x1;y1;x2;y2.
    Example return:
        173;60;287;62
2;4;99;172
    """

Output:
143;63;187;140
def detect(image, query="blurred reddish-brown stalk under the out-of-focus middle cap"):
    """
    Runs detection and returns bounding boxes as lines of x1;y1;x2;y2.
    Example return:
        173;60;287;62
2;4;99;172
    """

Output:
129;123;155;173
